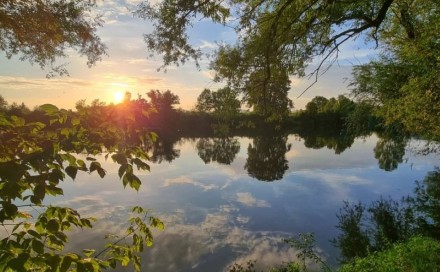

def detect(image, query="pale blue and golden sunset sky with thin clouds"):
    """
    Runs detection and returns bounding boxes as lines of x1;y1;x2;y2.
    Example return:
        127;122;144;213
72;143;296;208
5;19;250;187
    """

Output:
0;0;374;110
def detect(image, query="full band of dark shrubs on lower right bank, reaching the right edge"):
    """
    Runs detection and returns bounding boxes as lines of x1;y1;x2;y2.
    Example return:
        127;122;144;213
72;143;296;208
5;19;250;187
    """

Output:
332;168;440;263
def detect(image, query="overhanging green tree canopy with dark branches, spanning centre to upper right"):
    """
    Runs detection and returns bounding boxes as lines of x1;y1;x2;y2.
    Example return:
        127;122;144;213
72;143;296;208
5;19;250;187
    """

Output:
136;0;440;137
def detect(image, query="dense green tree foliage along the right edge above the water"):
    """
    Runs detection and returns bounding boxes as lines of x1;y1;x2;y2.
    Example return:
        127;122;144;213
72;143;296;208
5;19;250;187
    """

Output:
352;1;440;139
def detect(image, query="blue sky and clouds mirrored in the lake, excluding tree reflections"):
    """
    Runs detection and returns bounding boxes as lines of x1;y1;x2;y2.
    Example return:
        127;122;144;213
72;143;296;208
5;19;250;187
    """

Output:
47;135;439;271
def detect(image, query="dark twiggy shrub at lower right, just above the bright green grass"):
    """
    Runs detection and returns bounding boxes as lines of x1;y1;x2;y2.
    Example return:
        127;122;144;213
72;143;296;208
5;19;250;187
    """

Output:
332;198;417;263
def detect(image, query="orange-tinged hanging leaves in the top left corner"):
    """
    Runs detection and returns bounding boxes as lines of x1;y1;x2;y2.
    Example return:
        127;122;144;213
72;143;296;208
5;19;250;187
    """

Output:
0;0;106;76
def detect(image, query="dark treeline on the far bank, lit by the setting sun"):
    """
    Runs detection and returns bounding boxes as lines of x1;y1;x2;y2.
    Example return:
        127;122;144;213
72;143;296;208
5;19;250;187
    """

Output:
0;90;384;140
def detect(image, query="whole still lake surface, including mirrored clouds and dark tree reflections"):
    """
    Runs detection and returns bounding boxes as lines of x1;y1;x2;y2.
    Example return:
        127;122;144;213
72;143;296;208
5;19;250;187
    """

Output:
1;126;440;271
